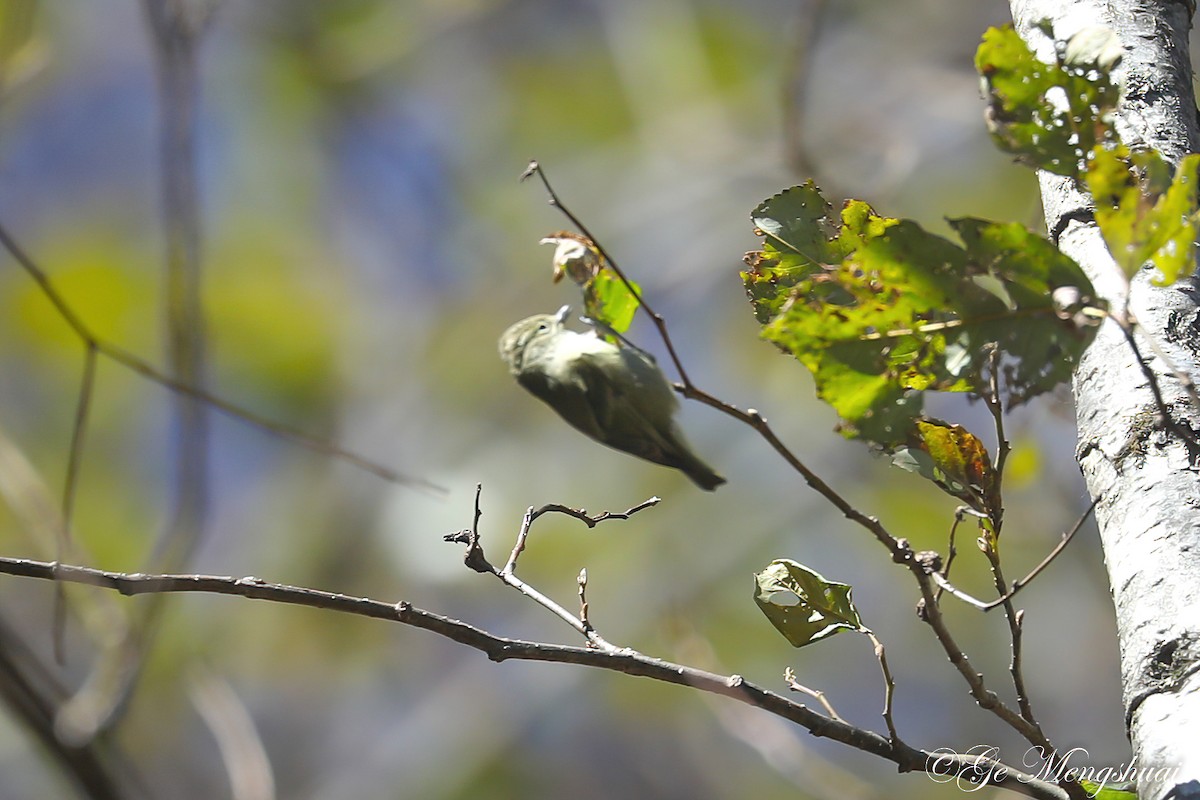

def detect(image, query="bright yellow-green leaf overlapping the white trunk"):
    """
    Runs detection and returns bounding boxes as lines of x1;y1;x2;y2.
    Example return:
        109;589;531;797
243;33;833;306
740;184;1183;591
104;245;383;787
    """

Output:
1086;145;1200;285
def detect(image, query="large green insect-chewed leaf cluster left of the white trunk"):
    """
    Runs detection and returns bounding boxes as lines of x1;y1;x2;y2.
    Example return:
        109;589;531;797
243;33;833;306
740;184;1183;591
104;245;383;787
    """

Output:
742;182;1094;447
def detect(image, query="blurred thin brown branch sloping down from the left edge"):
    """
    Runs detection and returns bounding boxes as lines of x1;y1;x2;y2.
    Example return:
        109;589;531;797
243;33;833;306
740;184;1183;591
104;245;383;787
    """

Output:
0;224;436;494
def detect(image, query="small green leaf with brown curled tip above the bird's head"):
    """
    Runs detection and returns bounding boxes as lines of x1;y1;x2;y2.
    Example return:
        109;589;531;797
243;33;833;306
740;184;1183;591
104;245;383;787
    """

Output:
541;230;641;333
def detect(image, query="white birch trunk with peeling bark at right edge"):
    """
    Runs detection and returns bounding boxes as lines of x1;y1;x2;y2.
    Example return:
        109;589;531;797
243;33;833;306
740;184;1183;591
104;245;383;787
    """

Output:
1010;0;1200;800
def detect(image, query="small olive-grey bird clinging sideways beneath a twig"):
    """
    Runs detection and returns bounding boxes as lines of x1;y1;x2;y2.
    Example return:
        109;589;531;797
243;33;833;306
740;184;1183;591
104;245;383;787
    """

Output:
500;306;725;492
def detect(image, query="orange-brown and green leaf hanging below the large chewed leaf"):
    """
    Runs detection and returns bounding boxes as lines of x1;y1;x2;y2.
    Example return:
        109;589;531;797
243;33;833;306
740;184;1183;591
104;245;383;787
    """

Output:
892;420;1001;522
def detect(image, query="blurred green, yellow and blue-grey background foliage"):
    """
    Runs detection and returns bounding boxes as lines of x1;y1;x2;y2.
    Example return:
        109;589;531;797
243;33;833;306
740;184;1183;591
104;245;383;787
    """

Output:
0;0;1142;800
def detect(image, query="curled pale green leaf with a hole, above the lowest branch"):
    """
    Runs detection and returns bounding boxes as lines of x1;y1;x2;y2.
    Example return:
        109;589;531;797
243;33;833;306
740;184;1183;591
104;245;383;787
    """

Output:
754;559;863;648
